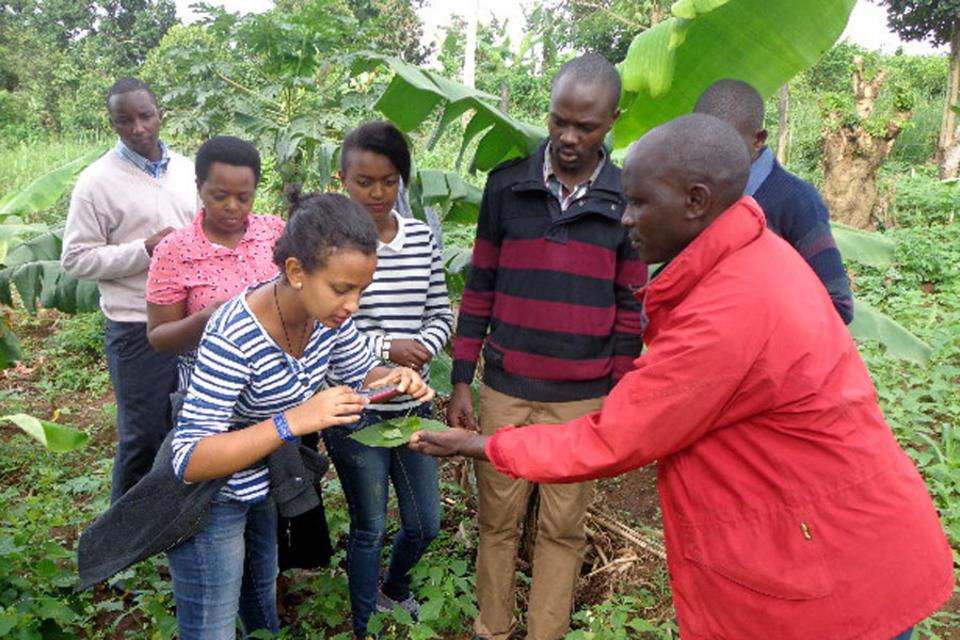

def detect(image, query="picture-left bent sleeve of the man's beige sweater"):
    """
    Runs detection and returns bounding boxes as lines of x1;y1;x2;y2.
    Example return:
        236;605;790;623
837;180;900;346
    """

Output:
60;189;150;280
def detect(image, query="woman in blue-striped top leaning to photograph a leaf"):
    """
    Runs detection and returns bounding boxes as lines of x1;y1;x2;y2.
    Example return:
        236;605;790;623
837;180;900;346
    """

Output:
169;194;433;640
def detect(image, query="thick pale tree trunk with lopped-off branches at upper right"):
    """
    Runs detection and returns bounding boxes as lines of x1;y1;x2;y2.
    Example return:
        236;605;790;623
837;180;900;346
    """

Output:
820;56;911;229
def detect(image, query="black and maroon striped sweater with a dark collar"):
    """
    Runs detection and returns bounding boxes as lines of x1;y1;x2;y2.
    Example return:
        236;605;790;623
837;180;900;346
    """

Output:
452;144;647;402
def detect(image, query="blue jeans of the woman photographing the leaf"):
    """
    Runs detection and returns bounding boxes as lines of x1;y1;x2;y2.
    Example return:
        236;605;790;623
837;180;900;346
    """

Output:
167;496;280;640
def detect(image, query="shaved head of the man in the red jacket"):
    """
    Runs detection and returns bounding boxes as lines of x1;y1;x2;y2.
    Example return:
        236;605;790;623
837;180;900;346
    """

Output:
623;114;750;263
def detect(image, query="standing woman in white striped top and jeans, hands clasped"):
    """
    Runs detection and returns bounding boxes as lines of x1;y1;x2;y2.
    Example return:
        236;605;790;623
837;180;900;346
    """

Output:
323;122;453;638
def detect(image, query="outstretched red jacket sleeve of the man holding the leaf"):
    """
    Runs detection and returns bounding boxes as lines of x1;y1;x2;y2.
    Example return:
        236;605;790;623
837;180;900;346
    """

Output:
486;288;768;482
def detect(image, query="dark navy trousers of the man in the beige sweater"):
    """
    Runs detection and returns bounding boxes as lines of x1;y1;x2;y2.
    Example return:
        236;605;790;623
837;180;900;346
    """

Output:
104;320;177;504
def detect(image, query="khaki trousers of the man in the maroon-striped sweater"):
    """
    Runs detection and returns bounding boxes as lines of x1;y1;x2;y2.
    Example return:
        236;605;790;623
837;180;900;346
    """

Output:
474;386;603;640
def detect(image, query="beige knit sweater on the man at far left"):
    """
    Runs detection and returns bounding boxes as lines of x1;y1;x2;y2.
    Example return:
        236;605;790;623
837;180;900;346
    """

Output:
60;149;198;322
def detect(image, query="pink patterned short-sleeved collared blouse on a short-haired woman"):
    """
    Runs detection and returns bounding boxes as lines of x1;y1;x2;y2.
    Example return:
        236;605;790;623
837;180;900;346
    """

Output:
147;209;285;315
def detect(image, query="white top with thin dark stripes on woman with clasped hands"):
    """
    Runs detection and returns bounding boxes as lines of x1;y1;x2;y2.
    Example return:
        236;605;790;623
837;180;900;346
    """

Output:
354;211;453;411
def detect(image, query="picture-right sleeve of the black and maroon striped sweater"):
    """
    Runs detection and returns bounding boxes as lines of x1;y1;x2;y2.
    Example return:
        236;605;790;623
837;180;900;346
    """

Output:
613;234;647;380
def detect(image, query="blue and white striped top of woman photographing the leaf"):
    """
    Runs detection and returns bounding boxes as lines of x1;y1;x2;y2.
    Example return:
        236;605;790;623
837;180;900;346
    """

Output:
173;290;378;503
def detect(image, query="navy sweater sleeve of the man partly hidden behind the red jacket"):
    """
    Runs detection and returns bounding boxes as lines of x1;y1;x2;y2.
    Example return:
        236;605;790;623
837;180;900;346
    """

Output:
782;183;853;324
